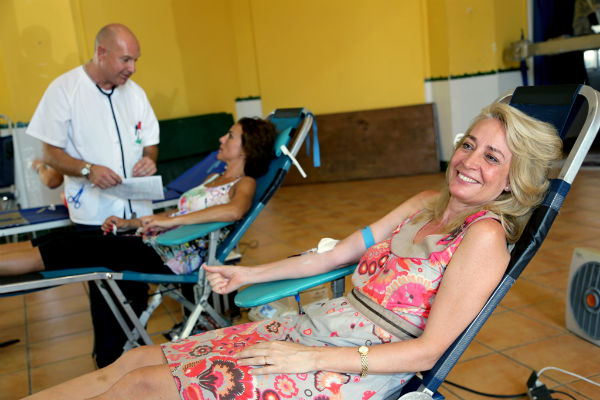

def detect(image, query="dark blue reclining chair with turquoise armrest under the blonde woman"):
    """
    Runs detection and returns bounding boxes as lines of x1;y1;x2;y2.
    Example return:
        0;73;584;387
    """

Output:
235;85;600;399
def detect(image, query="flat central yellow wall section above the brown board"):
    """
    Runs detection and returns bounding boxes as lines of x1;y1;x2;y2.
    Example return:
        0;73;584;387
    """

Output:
252;0;424;113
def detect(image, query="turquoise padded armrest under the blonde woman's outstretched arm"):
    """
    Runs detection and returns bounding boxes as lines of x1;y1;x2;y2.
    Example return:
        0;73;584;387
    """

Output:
235;264;356;307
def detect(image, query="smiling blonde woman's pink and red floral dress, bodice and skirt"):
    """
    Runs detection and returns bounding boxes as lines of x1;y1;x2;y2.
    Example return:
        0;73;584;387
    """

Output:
162;211;495;400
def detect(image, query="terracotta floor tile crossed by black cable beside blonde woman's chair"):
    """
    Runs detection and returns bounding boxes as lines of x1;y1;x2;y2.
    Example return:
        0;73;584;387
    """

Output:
446;353;531;400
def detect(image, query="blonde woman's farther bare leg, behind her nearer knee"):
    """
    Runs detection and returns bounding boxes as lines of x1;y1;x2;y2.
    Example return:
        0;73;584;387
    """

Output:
27;345;166;400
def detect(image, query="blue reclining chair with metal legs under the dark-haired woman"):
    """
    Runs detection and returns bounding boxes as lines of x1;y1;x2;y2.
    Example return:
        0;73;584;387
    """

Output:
0;108;318;349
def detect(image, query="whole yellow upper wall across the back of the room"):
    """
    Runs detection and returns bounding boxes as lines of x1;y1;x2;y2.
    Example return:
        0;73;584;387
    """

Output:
0;0;526;121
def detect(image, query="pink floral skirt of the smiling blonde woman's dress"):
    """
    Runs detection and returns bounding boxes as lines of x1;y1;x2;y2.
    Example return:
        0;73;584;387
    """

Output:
162;298;411;400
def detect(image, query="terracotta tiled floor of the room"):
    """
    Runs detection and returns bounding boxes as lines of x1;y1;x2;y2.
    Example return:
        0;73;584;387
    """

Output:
0;171;600;399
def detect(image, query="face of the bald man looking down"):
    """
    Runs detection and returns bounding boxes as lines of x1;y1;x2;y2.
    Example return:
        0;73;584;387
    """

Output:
98;32;140;86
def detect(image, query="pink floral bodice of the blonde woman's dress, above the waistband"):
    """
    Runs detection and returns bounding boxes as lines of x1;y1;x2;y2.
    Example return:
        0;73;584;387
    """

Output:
352;210;499;329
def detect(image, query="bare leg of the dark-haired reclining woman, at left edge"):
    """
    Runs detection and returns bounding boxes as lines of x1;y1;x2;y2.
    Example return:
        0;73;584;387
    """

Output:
0;242;44;276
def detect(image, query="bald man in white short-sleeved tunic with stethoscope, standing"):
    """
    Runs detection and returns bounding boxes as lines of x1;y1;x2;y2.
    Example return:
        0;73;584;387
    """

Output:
27;24;159;367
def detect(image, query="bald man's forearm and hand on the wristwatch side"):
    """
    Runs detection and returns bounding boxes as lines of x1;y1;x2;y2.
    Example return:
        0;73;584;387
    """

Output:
43;143;121;189
